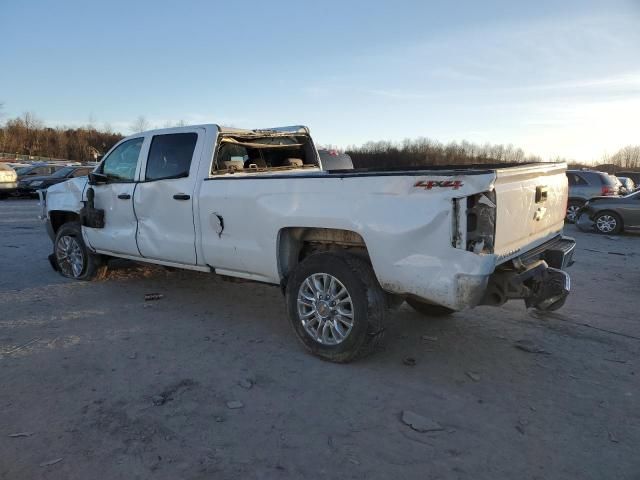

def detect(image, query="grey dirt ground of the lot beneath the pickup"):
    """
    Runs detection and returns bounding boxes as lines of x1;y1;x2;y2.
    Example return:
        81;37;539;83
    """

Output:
0;200;640;480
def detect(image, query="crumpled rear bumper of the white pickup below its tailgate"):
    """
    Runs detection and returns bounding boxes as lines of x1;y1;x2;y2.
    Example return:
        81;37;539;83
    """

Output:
480;237;576;311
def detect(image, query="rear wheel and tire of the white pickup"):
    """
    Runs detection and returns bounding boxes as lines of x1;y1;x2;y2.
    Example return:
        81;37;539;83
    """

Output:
286;252;387;363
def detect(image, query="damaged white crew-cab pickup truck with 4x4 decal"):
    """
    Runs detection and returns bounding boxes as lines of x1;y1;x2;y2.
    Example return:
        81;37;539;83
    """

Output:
42;125;575;362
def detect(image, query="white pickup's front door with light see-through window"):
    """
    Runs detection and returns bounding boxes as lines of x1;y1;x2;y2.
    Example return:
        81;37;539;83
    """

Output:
82;137;144;256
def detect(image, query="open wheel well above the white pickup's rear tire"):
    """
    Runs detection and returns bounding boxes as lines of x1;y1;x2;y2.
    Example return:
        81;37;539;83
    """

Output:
278;227;369;281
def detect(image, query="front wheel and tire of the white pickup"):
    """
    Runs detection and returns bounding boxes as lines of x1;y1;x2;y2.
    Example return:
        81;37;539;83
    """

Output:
53;222;107;280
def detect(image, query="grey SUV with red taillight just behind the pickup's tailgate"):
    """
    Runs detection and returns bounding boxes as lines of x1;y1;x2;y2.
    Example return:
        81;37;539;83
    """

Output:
566;169;618;223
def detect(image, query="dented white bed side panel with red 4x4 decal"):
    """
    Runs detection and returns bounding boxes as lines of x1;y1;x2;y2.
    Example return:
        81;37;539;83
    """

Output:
200;173;495;308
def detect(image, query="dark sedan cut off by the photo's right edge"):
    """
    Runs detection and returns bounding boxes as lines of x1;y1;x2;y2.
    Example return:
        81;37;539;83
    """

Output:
576;191;640;235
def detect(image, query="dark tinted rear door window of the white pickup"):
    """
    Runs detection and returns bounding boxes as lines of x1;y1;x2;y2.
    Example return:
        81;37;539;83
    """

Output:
145;133;198;180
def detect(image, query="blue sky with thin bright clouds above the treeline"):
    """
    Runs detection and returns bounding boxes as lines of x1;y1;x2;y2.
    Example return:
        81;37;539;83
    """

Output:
0;0;640;162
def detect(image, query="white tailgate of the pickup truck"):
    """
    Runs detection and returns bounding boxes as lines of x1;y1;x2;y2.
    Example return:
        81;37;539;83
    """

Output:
494;163;568;257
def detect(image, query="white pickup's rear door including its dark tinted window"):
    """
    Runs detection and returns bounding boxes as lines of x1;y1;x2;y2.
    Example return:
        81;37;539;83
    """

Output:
134;128;205;265
